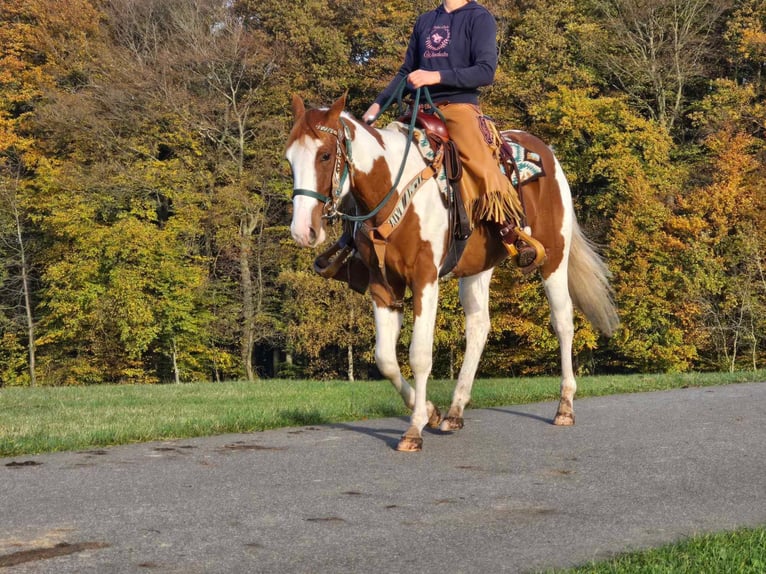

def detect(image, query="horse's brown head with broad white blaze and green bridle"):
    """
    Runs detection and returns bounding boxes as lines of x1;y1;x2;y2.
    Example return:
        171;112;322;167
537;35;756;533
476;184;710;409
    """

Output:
285;91;348;247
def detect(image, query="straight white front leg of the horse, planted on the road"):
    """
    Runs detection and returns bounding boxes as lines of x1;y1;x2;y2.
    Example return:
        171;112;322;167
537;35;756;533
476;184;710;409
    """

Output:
396;281;441;452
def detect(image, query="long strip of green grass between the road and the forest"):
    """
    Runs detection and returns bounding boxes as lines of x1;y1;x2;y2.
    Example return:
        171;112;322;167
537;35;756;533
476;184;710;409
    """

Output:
0;372;766;456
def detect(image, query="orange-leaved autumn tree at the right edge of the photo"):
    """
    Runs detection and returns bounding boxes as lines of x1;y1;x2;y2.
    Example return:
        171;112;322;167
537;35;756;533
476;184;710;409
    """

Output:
673;81;766;370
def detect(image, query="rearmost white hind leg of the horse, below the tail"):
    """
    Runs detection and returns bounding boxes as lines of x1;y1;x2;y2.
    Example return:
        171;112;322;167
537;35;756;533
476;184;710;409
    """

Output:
543;261;577;426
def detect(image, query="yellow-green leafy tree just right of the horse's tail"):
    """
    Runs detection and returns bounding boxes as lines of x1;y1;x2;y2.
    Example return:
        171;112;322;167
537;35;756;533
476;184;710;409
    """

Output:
539;88;708;370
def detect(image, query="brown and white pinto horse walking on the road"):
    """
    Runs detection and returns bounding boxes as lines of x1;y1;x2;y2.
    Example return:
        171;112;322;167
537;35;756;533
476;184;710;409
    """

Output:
285;95;619;452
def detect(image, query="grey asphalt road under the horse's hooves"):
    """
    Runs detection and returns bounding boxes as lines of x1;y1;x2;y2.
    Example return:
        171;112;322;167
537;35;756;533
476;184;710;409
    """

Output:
0;383;766;574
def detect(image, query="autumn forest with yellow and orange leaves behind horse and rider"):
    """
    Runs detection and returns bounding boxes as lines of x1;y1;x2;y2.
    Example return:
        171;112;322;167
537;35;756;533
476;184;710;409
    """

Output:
0;0;766;386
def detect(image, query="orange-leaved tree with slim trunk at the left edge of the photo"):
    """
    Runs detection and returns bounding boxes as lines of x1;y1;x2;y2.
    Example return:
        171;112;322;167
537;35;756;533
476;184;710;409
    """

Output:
0;0;100;385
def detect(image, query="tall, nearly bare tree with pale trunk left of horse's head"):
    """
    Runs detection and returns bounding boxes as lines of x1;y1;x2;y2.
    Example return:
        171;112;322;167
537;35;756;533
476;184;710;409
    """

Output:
102;0;292;380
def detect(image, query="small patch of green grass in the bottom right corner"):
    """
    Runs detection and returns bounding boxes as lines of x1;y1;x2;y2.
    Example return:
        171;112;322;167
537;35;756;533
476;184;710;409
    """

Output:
553;528;766;574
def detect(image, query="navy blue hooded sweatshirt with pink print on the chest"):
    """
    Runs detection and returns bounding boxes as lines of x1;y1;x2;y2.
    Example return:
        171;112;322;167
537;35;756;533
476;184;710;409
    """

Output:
375;2;497;105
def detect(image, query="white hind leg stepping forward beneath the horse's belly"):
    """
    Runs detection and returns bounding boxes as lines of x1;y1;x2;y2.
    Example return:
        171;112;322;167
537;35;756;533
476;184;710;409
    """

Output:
441;269;493;431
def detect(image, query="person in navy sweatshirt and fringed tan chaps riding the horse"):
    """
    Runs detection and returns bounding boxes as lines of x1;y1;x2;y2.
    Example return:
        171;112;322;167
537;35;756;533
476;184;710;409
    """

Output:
362;0;538;267
